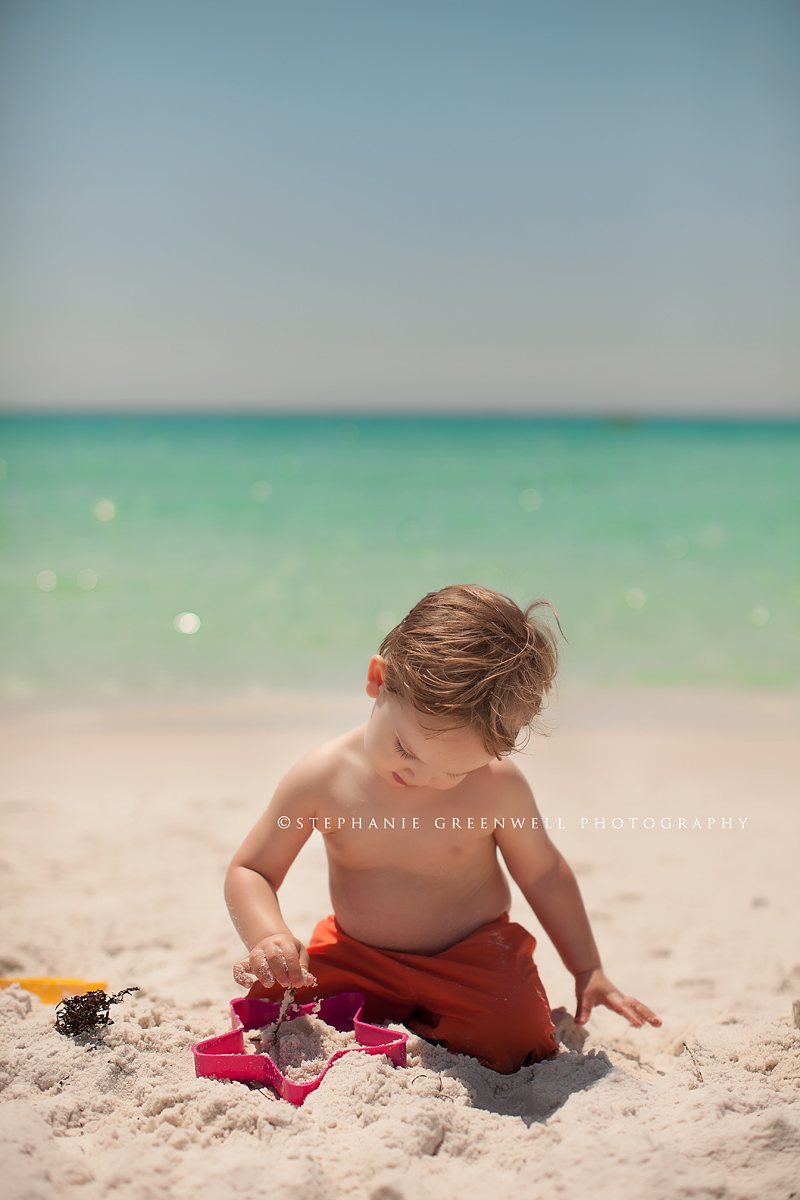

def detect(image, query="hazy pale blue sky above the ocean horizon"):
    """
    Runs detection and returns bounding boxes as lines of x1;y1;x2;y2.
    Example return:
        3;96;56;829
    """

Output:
0;0;800;414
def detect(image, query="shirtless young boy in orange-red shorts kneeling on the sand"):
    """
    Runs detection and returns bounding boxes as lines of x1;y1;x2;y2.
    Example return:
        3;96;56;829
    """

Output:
225;584;661;1074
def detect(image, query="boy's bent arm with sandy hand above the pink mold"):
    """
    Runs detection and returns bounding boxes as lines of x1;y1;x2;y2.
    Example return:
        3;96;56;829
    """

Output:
225;760;315;988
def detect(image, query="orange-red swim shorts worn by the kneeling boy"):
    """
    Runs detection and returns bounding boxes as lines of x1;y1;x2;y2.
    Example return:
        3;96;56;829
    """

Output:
249;913;557;1075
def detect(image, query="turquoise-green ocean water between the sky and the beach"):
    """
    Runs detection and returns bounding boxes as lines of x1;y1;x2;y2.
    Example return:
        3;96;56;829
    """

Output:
0;416;800;698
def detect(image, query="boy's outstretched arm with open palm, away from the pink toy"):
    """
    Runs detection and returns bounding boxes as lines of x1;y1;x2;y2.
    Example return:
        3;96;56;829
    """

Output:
494;769;661;1026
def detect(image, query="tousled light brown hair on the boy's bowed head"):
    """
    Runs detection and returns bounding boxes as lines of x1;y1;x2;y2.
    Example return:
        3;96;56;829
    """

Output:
380;583;560;757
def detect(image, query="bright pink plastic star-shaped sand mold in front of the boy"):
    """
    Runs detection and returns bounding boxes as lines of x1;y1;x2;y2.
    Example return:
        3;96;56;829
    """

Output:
192;991;408;1104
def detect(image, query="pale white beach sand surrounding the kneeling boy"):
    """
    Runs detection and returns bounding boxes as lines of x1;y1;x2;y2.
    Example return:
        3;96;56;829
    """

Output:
0;692;800;1200
